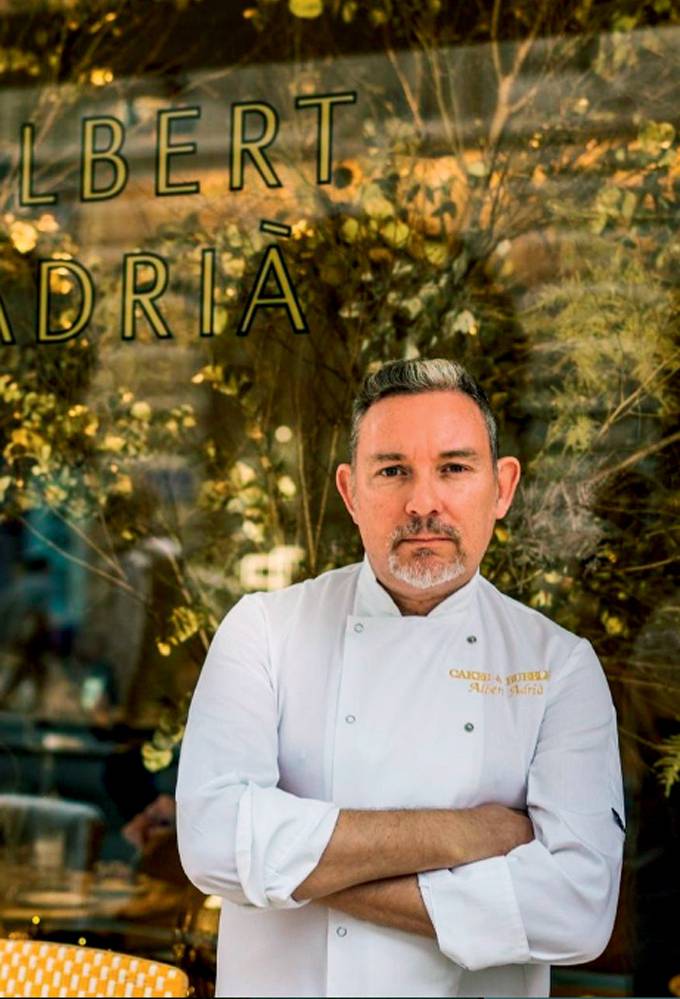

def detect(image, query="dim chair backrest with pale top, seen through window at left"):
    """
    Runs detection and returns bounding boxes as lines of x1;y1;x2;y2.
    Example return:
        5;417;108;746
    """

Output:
0;794;104;870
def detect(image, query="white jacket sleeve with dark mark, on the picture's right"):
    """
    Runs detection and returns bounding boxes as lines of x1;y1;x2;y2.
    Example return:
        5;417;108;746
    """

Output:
419;640;624;971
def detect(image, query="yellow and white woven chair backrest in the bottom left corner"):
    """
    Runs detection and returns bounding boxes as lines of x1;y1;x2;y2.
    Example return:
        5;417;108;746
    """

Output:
0;939;189;999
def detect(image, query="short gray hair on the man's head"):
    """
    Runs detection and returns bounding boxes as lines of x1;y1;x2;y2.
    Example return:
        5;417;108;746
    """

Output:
350;357;498;467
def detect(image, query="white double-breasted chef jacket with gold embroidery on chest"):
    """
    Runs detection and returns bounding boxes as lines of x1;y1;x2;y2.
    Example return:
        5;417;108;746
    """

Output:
177;560;624;996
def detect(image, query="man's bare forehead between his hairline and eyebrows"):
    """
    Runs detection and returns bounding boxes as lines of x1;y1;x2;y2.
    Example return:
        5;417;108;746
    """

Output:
357;390;489;458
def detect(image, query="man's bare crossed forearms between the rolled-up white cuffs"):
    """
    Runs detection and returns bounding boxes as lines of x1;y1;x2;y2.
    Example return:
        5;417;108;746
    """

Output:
293;804;533;937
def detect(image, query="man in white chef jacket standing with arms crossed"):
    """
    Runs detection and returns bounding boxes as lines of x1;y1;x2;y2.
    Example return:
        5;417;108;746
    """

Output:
177;360;623;996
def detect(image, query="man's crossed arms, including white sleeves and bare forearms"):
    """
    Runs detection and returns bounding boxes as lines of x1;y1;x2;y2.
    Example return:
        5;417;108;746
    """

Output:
177;598;623;970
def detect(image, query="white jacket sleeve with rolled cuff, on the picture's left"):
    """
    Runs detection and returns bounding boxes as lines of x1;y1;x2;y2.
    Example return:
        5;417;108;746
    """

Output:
177;595;339;908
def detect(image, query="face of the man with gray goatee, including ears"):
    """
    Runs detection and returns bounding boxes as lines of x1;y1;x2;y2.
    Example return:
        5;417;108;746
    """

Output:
337;391;519;606
